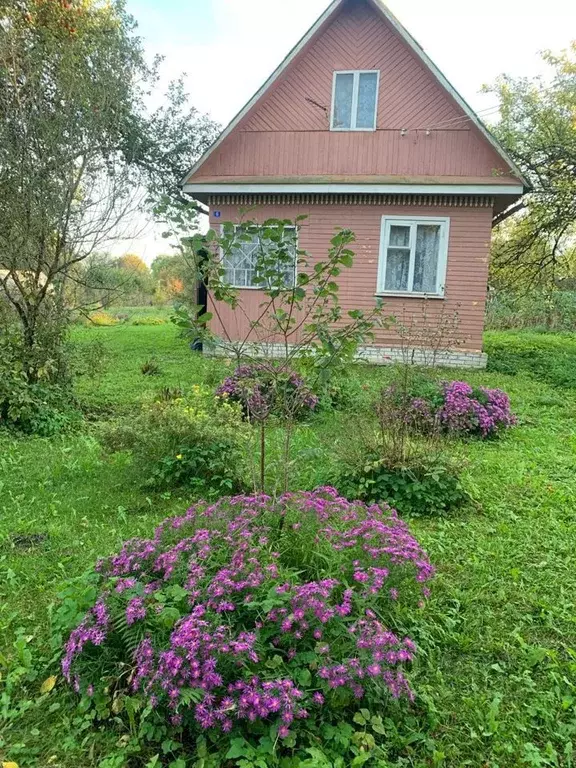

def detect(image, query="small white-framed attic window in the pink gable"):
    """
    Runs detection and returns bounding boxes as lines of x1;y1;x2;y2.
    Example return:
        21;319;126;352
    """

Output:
331;70;380;131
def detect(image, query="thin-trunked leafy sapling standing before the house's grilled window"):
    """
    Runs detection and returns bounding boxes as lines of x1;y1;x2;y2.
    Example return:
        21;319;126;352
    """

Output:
174;217;392;489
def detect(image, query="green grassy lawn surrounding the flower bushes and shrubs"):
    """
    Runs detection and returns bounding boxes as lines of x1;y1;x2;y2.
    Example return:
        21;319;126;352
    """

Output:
0;324;576;768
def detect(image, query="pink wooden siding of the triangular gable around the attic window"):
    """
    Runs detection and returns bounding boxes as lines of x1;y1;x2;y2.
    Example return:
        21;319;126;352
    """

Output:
190;0;511;183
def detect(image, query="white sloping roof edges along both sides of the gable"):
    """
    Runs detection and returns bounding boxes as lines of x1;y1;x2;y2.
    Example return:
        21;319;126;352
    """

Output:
182;0;529;188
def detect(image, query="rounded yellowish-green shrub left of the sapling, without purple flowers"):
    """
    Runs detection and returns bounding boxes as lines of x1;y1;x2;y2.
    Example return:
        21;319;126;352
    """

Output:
101;386;248;497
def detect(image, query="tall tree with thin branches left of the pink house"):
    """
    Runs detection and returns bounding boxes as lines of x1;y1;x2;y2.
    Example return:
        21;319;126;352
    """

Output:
0;0;216;380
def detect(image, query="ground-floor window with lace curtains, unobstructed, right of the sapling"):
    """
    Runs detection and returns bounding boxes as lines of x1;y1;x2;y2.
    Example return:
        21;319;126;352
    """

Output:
377;216;450;296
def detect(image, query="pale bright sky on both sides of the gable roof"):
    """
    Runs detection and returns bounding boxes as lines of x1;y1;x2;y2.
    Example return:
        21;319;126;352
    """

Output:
115;0;576;262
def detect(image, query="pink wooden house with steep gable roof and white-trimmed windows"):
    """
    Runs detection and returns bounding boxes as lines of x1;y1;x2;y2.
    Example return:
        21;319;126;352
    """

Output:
183;0;526;367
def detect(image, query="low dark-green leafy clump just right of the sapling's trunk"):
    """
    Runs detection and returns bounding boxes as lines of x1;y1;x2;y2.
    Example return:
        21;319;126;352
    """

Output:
334;453;470;516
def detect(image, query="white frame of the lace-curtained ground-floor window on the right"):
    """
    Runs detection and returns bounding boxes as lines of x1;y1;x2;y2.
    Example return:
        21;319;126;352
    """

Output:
376;216;450;299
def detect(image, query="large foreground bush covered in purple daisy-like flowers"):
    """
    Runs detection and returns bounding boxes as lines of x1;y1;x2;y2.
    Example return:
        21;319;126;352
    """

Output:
62;488;434;764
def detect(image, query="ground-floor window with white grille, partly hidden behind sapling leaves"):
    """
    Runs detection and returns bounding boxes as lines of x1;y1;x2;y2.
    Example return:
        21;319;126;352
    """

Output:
222;224;298;289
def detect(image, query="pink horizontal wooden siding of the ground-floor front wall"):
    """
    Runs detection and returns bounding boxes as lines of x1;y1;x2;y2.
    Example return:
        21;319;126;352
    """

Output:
206;204;492;351
